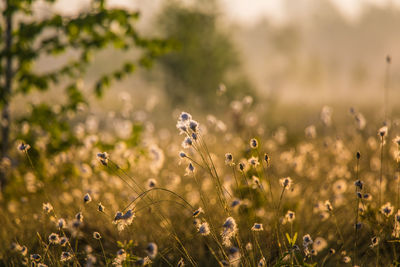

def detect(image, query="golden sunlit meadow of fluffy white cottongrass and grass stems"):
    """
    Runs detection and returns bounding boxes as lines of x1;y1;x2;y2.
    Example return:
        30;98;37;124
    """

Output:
0;94;400;266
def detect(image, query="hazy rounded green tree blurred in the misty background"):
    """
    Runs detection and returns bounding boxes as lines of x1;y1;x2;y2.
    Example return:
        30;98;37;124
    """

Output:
159;0;253;108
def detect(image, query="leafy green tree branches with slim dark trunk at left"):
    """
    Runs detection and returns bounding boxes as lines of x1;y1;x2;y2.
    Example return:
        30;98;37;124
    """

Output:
0;0;170;188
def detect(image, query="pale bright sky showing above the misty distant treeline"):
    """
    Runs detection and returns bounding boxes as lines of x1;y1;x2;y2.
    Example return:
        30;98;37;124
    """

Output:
50;0;400;24
